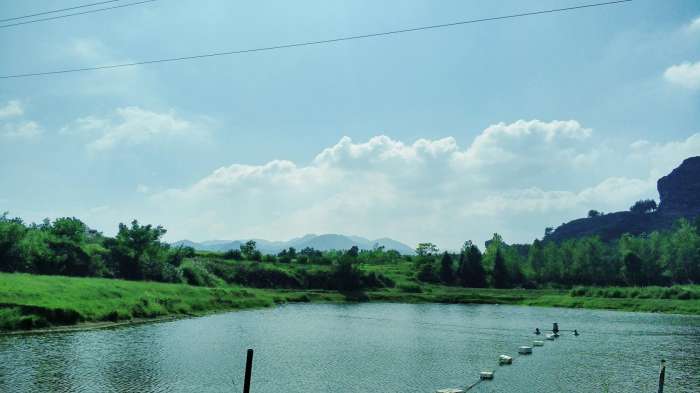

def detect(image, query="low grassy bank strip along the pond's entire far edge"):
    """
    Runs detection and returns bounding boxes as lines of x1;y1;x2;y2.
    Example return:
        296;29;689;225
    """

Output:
0;273;700;331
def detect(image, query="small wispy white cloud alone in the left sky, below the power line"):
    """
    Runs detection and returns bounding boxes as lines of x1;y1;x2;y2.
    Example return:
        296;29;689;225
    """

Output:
60;107;206;153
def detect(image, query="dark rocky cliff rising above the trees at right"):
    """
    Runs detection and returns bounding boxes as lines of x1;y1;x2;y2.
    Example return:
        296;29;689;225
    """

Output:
545;157;700;241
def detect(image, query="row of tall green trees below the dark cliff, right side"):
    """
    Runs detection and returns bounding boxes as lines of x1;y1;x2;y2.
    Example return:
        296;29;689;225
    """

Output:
416;218;700;288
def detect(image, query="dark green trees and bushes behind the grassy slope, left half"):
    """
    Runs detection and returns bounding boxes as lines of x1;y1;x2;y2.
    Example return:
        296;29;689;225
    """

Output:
0;214;400;291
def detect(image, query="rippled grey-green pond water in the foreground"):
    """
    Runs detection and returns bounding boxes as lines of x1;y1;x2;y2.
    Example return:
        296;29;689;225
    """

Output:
0;303;700;393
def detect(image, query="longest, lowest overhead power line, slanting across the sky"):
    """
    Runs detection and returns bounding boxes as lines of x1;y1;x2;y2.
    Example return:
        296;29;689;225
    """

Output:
0;0;633;79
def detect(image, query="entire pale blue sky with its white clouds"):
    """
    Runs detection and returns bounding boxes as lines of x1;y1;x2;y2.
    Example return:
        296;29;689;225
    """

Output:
0;0;700;249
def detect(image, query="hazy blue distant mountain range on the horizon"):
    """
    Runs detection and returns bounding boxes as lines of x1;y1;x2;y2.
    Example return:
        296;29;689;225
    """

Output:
172;234;414;255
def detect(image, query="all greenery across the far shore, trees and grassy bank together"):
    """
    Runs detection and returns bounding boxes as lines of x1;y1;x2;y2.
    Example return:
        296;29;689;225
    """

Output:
0;210;700;330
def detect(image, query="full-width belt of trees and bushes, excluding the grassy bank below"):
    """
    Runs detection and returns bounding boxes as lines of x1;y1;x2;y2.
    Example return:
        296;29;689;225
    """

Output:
0;214;700;291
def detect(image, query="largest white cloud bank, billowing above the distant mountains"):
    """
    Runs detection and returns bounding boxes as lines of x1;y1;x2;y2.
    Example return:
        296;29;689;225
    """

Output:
138;120;700;248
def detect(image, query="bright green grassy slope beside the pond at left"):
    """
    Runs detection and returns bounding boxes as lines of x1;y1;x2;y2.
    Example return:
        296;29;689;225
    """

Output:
0;273;273;330
